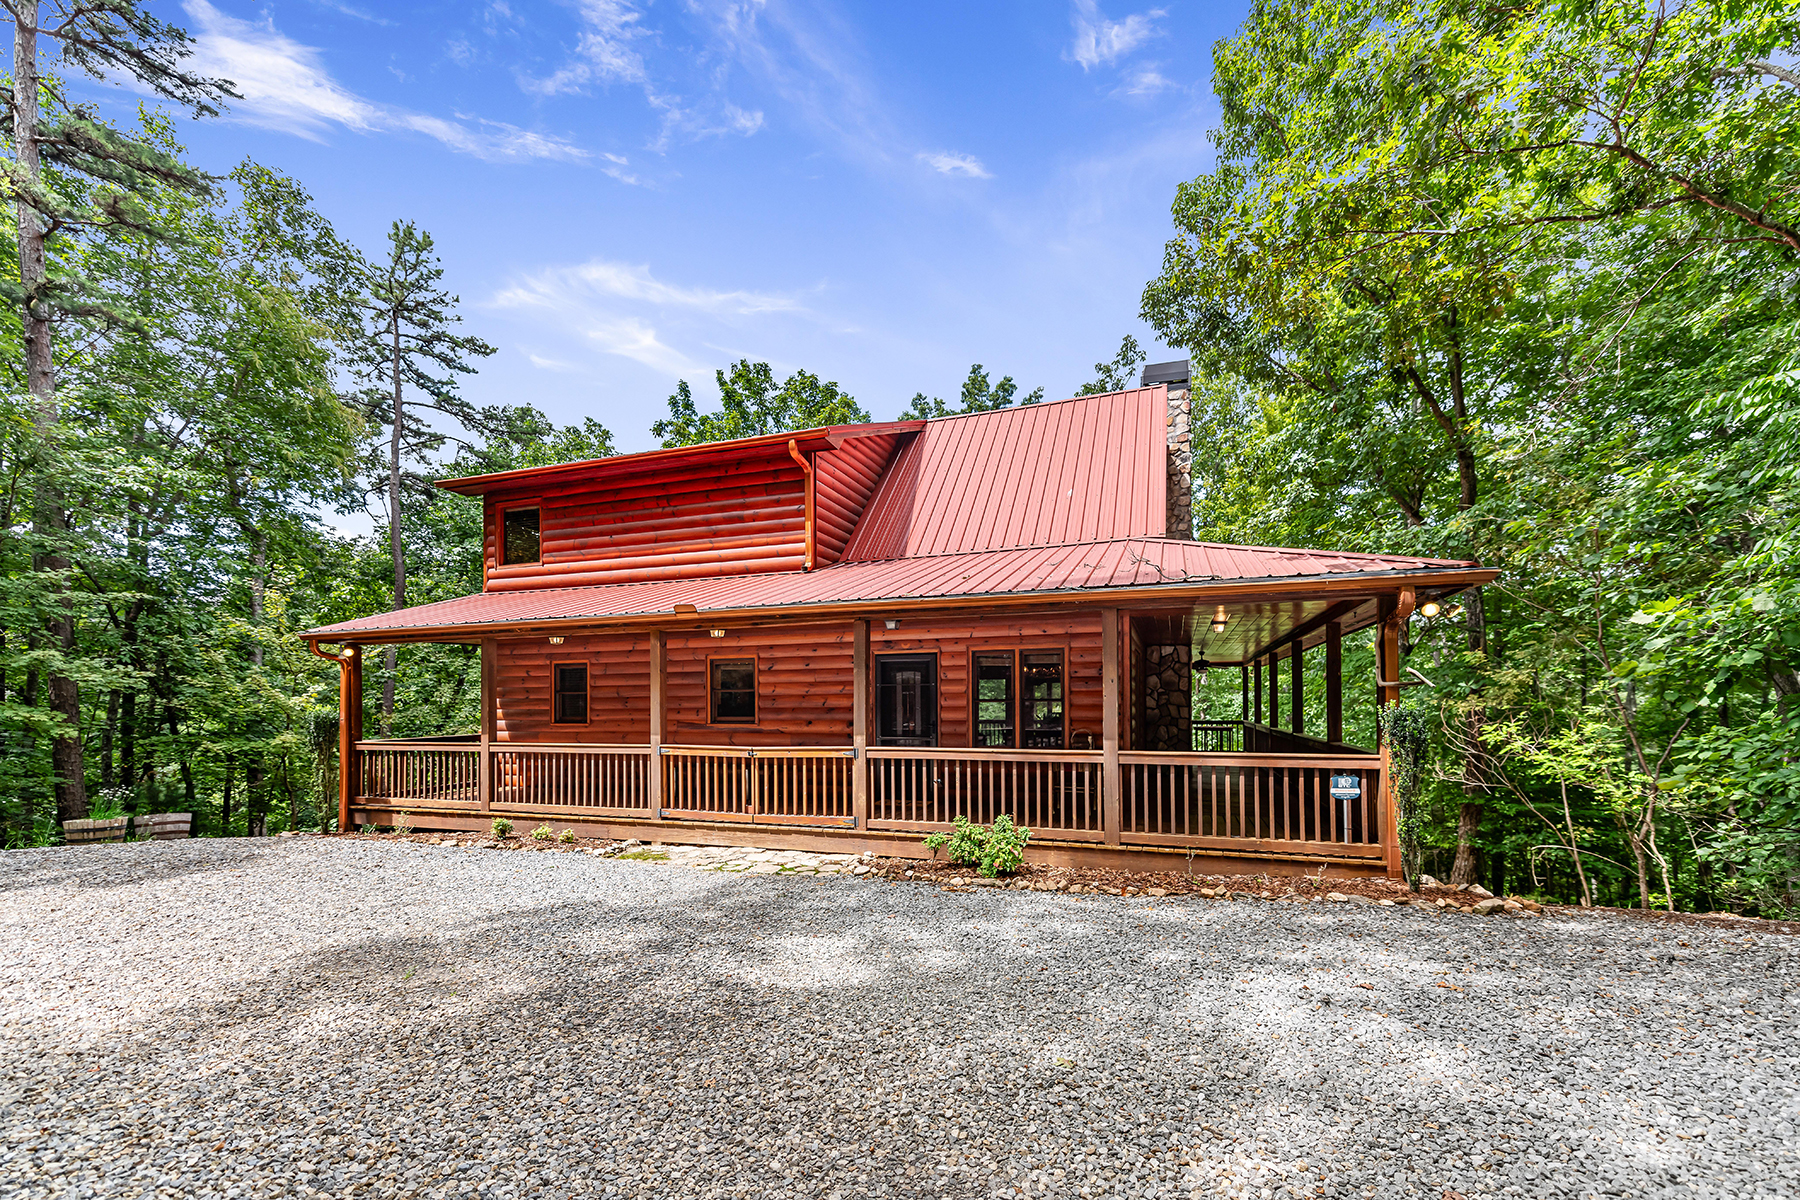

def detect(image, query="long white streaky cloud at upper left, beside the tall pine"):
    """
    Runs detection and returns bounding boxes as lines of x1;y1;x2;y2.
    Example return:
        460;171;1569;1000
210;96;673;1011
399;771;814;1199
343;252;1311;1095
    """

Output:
184;0;587;162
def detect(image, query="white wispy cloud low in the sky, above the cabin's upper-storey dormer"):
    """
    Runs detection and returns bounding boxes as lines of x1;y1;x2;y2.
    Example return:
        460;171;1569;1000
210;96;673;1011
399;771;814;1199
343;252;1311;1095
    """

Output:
490;259;806;378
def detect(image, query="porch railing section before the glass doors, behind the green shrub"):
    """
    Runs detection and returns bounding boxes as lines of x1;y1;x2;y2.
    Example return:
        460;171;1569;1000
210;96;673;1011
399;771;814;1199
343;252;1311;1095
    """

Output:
869;748;1105;842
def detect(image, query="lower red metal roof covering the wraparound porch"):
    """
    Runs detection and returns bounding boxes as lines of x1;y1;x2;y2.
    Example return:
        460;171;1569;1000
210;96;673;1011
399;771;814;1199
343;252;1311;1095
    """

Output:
302;538;1478;642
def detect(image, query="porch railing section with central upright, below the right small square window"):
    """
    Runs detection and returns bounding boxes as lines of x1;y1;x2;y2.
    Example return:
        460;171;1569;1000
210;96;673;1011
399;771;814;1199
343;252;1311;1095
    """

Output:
661;747;857;826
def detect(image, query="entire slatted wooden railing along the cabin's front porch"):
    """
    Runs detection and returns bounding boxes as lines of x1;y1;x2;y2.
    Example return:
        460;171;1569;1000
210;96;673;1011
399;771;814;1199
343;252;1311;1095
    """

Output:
355;727;1384;860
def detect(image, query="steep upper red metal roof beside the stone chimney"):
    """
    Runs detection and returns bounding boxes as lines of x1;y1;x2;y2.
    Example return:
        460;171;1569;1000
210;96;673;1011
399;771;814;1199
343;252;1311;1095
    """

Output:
844;387;1168;561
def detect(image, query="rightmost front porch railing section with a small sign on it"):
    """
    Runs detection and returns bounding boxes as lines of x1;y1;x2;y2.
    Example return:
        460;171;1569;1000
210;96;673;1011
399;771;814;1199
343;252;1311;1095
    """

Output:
1120;752;1381;855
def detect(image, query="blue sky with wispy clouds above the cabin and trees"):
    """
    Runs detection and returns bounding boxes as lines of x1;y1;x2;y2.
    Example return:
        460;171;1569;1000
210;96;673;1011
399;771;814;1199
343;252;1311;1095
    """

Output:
147;0;1242;450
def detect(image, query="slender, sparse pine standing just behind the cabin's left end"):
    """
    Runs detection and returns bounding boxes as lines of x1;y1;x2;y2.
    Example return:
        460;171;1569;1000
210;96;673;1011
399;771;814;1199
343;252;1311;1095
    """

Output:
347;221;495;729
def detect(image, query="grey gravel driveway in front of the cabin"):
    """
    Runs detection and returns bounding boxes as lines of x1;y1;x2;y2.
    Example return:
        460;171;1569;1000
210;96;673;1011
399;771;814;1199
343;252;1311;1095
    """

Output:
0;838;1800;1200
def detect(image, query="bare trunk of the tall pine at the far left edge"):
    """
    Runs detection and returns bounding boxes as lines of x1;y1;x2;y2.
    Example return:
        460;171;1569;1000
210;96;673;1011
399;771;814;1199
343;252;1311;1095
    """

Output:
13;0;88;822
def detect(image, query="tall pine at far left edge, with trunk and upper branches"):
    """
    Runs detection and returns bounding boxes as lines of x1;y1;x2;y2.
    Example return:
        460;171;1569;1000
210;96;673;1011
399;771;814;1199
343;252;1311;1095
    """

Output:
0;0;234;820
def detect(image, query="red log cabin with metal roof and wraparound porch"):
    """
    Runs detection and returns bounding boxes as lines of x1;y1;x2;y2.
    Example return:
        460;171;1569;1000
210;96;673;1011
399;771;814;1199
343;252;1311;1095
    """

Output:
302;380;1496;876
